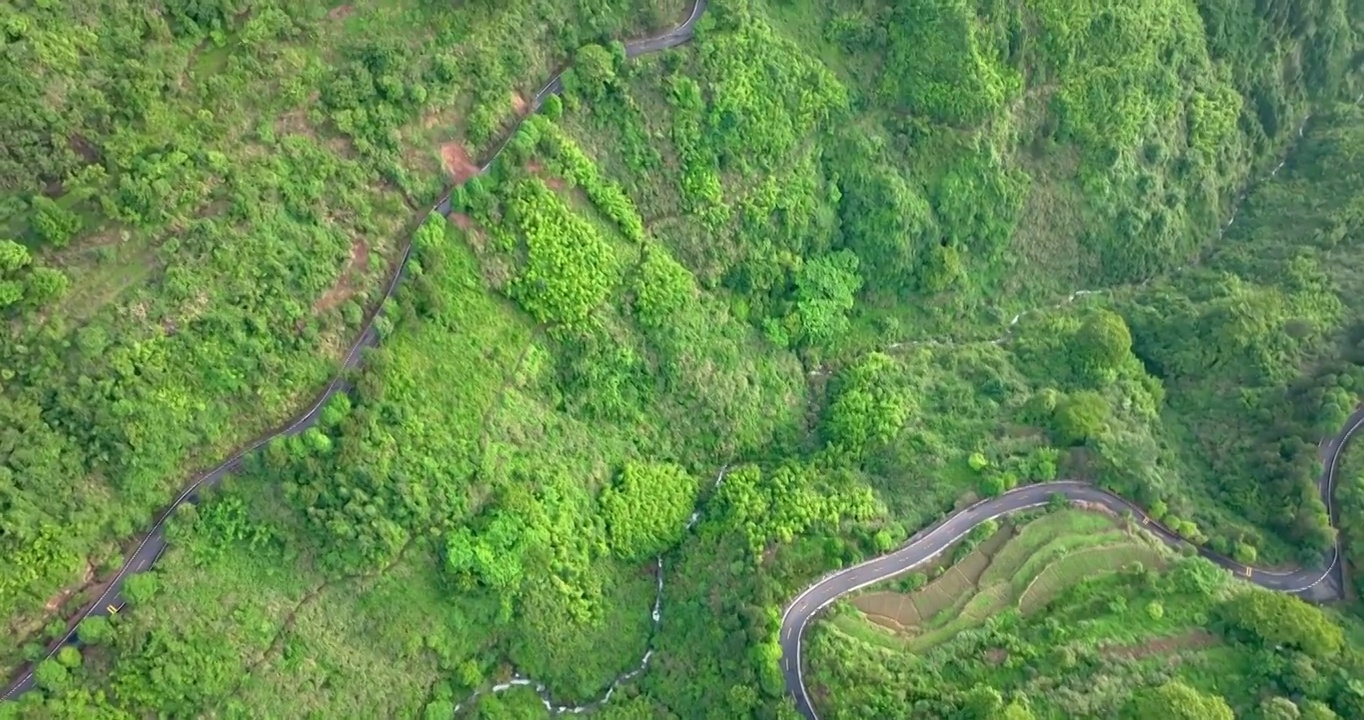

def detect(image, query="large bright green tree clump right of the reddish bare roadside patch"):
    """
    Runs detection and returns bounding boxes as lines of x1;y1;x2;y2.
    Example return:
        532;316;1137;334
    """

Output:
507;179;621;325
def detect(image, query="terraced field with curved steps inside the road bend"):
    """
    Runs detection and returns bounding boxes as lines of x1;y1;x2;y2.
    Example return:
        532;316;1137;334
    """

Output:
836;510;1169;652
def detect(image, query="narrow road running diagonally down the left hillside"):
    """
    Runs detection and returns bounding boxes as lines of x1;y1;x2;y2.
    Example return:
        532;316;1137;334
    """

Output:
0;0;708;701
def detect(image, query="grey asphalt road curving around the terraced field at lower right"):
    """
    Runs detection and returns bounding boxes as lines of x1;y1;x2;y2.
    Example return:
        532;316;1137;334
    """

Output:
779;408;1364;720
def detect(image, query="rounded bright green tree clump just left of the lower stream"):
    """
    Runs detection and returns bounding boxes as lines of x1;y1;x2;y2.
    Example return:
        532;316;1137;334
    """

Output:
599;462;697;560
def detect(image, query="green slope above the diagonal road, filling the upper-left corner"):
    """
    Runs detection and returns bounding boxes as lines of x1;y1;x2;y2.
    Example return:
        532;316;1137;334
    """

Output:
0;0;682;663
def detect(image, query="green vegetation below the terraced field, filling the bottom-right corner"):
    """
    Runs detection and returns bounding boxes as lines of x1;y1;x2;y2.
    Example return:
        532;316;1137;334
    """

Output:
806;529;1364;720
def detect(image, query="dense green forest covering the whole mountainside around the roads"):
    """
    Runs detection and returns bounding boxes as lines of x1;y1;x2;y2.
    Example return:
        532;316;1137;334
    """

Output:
8;0;1364;719
